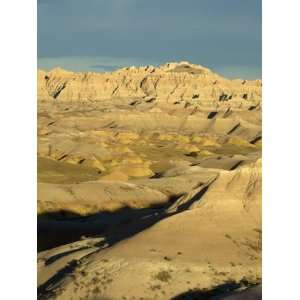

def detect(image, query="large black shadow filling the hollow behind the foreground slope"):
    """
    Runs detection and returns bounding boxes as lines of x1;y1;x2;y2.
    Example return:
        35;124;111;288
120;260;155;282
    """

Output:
37;183;211;251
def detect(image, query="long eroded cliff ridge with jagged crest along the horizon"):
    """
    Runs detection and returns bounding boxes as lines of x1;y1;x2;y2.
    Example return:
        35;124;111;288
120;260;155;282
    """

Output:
38;62;261;106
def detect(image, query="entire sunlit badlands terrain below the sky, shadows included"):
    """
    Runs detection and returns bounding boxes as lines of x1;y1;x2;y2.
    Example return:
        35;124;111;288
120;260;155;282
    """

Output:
38;62;262;300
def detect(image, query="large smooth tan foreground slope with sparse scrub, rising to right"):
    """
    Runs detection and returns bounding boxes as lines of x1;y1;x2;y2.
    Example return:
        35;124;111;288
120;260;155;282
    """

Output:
41;162;261;299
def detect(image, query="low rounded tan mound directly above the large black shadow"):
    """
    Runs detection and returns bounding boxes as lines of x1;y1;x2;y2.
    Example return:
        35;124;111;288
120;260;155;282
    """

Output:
37;180;168;216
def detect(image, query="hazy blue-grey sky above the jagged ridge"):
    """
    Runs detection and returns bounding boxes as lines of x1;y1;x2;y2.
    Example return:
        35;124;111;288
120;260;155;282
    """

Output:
38;0;262;79
